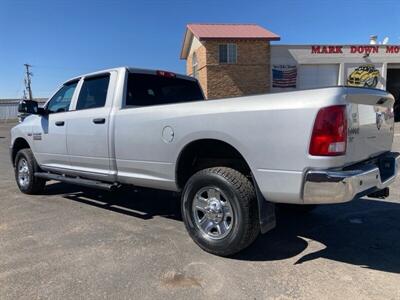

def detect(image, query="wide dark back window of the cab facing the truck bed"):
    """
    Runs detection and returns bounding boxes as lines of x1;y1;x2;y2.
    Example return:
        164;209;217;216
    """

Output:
125;72;204;107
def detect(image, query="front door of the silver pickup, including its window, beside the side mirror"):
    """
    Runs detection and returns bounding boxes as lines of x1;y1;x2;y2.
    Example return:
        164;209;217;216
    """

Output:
32;80;78;170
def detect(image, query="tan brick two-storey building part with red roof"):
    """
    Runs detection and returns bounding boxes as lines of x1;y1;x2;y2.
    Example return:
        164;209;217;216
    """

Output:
181;24;280;98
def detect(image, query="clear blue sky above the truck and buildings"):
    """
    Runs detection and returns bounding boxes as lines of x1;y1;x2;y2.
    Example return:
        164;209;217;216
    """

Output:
0;0;400;99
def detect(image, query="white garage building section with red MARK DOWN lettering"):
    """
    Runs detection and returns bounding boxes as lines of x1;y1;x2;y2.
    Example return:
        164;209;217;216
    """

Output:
270;45;400;115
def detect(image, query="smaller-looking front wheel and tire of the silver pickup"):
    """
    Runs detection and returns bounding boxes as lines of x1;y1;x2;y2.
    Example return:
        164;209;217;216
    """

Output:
14;149;46;195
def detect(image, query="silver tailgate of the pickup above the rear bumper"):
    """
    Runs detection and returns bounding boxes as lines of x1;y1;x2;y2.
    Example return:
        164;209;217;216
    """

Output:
346;88;394;163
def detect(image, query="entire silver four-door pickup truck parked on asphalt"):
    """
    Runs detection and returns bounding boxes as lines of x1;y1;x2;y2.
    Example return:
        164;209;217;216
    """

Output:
10;68;399;256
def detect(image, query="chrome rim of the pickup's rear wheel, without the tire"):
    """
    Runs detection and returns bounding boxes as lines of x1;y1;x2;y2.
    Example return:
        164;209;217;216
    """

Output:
192;187;234;239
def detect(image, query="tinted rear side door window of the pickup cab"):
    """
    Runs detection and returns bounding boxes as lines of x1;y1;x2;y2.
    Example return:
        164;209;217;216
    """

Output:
76;74;110;110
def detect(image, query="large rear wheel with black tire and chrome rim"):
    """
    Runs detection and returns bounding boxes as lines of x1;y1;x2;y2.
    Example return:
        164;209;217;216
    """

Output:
181;167;260;256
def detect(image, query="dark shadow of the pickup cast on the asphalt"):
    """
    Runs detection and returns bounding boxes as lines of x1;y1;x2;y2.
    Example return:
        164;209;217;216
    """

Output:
46;183;400;273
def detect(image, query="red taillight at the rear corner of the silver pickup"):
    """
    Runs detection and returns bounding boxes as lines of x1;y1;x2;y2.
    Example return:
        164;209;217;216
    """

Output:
309;105;347;156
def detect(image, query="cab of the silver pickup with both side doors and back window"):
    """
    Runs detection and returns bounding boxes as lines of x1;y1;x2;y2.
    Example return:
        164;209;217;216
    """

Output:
13;68;204;182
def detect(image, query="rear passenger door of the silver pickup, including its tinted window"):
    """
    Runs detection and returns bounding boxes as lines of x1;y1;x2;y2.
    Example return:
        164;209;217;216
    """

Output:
66;73;116;180
